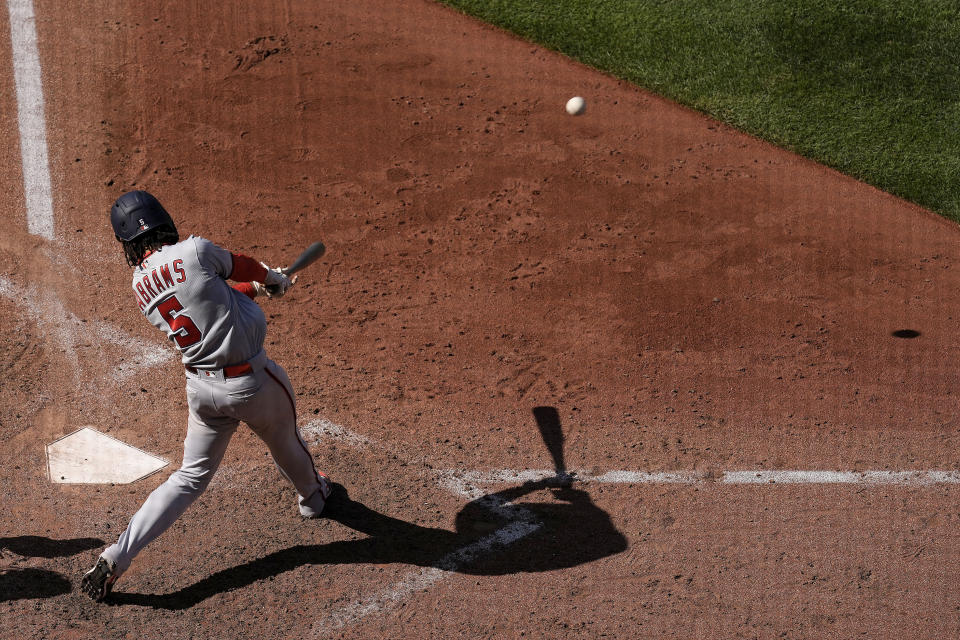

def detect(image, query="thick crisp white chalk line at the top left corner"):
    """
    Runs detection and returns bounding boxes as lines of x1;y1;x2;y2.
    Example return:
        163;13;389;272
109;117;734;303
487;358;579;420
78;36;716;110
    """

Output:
7;0;54;240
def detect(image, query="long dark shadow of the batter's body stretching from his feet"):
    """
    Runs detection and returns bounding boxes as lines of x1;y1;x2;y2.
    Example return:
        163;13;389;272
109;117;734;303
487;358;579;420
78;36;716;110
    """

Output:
108;479;627;610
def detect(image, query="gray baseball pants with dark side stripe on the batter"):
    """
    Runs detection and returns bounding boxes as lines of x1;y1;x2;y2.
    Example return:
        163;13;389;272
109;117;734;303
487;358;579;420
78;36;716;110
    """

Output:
101;352;329;574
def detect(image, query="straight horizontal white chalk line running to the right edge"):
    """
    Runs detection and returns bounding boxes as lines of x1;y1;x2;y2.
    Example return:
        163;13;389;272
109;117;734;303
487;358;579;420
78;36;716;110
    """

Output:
436;469;960;488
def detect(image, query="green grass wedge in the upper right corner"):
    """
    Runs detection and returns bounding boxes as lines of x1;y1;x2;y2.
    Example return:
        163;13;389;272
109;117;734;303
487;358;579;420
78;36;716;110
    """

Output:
442;0;960;220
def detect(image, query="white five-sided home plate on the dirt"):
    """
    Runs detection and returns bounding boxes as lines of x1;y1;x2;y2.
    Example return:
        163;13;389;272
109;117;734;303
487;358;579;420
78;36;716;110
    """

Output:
47;427;169;484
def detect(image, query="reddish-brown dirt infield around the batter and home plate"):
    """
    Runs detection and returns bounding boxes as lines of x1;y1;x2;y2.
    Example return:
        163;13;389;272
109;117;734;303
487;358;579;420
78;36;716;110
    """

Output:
0;0;960;638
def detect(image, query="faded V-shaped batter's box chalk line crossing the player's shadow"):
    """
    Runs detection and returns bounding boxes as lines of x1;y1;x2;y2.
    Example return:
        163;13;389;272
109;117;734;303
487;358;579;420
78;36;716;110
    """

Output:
300;419;543;636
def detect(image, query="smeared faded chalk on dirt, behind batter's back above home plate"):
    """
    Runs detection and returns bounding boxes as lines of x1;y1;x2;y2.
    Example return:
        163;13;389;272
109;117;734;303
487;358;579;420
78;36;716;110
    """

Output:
0;277;174;383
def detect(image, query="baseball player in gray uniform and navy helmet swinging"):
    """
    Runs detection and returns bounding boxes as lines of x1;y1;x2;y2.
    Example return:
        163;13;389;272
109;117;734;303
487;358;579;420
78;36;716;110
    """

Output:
81;191;331;601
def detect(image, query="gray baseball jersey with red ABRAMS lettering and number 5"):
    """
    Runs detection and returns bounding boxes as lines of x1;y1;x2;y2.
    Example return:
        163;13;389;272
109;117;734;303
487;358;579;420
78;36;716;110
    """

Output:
133;236;267;369
